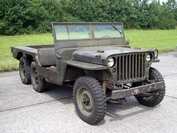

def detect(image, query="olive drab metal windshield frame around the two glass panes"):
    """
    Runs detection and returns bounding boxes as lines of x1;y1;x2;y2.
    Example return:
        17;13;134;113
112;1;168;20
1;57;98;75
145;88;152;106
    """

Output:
52;22;126;49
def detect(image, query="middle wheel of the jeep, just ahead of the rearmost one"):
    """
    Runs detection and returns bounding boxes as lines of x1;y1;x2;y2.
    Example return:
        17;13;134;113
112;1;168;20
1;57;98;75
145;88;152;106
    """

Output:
30;62;46;92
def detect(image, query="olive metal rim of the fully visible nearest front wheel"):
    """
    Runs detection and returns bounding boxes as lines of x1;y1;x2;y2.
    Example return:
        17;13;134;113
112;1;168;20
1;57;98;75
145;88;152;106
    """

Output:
77;87;93;116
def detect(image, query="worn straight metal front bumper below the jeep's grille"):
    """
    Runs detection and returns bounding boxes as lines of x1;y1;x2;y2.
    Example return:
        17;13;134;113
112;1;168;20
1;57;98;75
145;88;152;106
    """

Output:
111;81;164;99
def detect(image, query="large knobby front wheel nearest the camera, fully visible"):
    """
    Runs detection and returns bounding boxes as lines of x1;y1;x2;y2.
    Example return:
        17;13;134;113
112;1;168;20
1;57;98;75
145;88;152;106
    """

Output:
73;76;107;125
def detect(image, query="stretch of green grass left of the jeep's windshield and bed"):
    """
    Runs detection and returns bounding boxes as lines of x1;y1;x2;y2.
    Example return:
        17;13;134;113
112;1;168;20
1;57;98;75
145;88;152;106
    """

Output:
0;33;53;72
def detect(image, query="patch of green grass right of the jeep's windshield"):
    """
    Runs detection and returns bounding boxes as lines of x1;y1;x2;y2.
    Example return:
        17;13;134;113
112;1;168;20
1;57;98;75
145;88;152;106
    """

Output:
125;28;177;53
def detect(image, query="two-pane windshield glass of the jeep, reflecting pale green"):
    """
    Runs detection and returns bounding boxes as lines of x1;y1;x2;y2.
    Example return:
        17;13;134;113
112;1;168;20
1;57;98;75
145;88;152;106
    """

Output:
54;23;123;40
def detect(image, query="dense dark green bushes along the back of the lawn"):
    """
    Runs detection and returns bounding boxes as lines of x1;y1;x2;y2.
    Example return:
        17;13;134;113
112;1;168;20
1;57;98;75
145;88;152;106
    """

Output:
0;0;177;35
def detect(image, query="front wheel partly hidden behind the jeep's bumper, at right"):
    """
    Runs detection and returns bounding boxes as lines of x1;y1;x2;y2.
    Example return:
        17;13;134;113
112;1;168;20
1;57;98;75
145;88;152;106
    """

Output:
135;67;165;107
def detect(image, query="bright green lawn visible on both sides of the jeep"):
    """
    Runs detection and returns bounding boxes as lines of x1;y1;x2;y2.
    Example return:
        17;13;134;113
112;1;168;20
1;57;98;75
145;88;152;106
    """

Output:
0;29;177;72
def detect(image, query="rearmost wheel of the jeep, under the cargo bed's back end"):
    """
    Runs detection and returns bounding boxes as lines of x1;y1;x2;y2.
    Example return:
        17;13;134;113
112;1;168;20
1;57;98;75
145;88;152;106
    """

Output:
19;57;31;84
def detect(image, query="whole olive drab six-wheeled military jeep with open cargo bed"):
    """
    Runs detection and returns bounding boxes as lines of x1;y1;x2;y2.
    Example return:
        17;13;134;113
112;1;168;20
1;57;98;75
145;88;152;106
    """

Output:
11;22;165;124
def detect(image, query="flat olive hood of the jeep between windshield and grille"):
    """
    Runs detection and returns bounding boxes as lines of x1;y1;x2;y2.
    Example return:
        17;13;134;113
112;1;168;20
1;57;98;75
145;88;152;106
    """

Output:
72;46;146;65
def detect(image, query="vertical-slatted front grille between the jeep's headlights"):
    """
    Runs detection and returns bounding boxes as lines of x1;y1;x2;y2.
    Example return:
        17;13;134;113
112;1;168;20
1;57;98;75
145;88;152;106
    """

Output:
117;53;146;82
